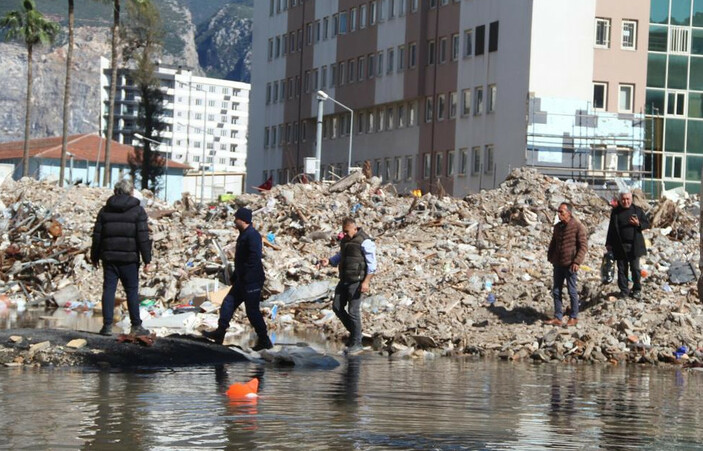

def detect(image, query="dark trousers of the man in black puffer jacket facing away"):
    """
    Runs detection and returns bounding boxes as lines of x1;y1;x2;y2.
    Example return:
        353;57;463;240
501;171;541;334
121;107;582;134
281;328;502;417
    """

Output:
102;262;142;327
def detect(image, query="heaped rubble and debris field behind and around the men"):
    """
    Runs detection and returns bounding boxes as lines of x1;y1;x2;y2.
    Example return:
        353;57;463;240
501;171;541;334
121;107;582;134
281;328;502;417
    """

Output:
0;169;703;364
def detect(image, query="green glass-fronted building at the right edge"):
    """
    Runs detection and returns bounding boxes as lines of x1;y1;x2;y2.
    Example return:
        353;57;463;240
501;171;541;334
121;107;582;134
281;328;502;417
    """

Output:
645;0;703;194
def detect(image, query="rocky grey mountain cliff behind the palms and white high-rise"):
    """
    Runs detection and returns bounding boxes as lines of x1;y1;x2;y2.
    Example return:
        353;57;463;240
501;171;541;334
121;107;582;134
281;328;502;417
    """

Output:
0;0;251;142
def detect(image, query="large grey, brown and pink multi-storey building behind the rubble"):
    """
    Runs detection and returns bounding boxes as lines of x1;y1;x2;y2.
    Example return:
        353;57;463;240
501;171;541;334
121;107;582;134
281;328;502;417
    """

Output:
247;0;648;195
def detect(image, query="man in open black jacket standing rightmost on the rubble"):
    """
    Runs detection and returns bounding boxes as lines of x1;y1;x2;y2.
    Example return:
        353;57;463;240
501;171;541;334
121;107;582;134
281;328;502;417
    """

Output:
605;193;649;299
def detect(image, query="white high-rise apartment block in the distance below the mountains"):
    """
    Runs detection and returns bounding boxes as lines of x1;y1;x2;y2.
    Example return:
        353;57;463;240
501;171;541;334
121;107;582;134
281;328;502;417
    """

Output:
101;58;251;200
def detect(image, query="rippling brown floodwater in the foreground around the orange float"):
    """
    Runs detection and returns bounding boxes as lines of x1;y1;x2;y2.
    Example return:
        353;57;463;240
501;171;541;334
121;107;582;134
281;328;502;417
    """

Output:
0;312;703;450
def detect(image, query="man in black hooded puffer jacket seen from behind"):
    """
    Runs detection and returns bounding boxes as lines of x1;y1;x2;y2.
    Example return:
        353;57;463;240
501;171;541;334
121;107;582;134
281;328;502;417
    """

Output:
90;179;151;335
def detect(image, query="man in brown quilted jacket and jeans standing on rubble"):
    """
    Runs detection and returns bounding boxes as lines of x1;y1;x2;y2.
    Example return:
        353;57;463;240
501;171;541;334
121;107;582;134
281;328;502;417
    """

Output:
546;203;588;326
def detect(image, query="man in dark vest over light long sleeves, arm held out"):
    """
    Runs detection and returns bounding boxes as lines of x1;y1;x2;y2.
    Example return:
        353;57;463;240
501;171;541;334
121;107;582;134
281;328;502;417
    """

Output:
320;218;376;355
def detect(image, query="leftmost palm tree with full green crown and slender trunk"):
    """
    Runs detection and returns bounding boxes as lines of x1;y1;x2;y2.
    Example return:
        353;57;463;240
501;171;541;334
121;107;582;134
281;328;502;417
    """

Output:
0;0;60;177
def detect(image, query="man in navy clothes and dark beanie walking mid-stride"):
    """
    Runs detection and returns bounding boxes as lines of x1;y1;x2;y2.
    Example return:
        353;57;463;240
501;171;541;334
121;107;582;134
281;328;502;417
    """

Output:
203;208;273;351
